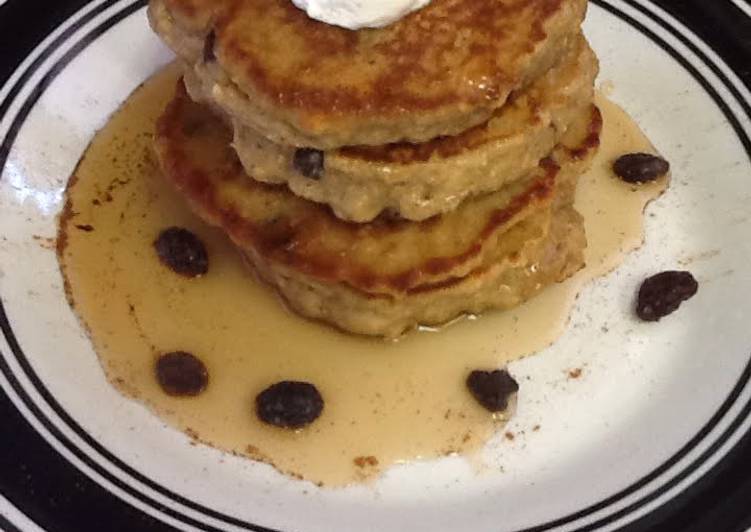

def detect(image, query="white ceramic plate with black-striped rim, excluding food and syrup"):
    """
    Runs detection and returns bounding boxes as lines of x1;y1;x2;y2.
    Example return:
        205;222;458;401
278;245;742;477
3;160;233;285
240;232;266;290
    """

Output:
0;0;751;532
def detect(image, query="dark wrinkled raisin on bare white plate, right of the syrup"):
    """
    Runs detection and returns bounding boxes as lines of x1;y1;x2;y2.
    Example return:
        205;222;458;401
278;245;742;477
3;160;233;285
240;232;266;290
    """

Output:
636;271;699;321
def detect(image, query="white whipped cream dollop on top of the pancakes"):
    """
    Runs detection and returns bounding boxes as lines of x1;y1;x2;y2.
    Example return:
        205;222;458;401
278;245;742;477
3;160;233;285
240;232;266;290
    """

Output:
292;0;430;30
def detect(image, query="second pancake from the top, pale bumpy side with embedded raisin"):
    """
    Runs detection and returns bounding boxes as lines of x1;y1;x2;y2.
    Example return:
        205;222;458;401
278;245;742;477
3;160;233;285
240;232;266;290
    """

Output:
203;36;598;222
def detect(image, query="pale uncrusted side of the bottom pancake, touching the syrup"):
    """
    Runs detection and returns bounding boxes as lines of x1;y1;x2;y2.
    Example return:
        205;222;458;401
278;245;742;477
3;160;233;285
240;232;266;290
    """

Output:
244;205;587;338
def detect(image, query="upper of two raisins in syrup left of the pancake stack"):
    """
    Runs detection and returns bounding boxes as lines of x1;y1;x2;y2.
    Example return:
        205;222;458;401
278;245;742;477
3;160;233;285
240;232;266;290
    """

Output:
154;227;209;277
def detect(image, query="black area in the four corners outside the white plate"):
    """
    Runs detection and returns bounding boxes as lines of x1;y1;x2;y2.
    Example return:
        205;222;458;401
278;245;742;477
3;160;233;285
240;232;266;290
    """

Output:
0;0;751;532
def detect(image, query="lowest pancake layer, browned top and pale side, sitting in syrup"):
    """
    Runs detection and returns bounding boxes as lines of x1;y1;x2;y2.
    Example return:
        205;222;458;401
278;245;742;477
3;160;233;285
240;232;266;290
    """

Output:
156;81;601;335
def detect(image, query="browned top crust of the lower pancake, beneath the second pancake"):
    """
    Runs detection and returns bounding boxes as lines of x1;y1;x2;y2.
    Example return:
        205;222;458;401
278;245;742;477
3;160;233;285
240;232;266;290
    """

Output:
157;81;600;293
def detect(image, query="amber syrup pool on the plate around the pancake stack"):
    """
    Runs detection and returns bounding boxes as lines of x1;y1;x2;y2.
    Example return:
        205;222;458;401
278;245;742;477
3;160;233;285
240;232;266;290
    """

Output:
58;66;667;486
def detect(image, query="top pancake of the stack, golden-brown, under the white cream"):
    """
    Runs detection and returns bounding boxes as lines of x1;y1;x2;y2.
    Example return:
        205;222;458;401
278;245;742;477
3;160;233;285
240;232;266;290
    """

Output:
150;0;586;149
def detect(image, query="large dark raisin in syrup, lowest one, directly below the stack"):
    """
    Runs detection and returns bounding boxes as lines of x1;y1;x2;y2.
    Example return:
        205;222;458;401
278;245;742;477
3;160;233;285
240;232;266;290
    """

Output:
256;381;323;429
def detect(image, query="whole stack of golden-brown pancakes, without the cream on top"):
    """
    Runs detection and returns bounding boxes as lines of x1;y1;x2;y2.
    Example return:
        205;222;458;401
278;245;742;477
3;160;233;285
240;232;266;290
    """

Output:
150;0;601;336
